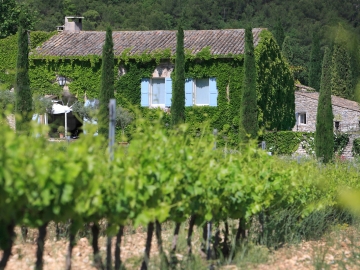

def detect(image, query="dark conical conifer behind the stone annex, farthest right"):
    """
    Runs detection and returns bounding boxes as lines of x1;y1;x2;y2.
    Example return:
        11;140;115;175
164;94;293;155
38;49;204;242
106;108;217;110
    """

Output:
331;30;354;99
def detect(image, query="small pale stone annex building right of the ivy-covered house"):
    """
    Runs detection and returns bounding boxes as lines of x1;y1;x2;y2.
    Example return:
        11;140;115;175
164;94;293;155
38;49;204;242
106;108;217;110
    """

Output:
292;85;360;158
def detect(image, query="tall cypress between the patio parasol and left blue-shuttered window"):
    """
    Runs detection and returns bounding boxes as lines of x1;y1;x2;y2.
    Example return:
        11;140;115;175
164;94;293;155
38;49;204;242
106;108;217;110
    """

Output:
98;26;114;136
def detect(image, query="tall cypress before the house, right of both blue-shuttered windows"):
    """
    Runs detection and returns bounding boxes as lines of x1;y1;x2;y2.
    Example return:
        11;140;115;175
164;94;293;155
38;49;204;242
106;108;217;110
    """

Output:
240;27;258;141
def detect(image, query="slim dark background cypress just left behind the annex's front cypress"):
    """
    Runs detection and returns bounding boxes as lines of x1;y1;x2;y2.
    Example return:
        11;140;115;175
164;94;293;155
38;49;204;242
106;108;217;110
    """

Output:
309;32;321;91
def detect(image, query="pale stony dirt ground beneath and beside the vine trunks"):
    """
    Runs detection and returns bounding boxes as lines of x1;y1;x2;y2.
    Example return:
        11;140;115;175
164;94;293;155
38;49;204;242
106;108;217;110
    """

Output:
0;223;360;270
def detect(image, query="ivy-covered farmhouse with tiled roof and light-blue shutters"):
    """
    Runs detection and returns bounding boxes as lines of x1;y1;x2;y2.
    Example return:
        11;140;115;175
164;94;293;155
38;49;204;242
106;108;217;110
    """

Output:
29;17;295;144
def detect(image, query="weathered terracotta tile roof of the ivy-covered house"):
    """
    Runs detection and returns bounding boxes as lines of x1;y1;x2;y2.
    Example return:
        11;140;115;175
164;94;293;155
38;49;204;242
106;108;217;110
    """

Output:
36;28;264;57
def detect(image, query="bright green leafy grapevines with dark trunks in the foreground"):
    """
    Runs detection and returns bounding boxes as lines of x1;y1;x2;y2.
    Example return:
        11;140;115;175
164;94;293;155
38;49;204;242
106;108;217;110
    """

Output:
0;110;360;269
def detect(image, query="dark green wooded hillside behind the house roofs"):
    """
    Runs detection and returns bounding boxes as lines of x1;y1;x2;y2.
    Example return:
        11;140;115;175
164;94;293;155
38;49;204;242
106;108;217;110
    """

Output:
0;0;360;101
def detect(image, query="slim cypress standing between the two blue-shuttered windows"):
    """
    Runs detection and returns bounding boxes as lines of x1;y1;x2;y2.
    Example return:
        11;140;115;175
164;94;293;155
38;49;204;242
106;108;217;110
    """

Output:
171;25;185;125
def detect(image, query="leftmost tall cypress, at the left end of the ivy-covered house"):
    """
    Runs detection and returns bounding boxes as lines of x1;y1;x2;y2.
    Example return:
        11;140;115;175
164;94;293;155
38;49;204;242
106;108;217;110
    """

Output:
15;12;32;133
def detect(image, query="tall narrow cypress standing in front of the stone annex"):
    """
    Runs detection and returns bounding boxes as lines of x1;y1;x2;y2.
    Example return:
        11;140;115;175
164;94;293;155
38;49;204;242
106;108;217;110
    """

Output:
315;48;334;163
